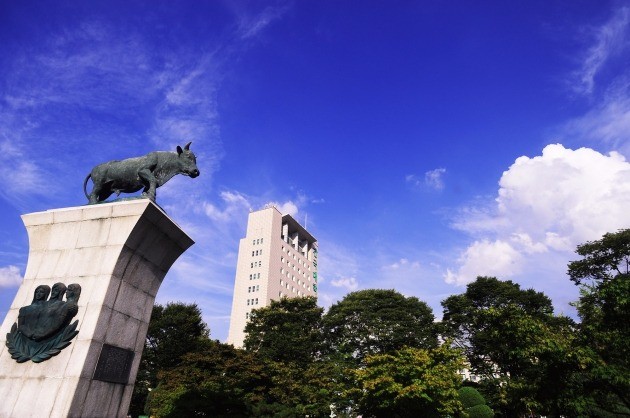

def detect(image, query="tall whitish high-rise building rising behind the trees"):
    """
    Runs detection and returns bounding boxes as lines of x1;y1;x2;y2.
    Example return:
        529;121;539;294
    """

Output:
227;207;317;347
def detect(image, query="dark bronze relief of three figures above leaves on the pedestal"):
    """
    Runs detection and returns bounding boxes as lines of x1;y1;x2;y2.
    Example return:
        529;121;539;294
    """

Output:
7;283;81;363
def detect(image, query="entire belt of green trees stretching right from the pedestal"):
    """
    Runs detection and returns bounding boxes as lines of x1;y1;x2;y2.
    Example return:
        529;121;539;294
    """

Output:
134;230;630;418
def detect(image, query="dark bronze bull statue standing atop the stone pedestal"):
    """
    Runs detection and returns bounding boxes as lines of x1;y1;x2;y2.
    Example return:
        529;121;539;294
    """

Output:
83;142;199;205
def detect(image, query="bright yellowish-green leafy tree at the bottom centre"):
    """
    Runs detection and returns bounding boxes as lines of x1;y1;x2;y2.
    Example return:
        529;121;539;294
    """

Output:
356;344;464;418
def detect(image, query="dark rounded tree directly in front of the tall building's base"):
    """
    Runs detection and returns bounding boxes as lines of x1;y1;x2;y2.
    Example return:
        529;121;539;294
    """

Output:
244;297;324;364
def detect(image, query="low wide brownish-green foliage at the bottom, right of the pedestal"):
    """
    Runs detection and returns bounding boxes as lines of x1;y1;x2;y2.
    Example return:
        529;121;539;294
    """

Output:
148;342;344;417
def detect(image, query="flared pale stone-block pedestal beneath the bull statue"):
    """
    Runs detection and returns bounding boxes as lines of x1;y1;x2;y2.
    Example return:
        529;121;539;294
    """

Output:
0;199;193;417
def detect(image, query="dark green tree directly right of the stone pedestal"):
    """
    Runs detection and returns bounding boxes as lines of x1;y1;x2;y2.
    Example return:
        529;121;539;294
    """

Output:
129;302;209;416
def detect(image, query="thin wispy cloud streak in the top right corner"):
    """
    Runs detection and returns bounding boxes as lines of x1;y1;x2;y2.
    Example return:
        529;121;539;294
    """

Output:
573;7;630;94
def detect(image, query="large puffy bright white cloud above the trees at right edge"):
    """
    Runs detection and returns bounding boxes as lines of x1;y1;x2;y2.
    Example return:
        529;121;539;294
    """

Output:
444;144;630;284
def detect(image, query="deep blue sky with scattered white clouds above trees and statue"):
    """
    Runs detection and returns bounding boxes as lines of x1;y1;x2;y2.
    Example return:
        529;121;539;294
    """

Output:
0;0;630;340
